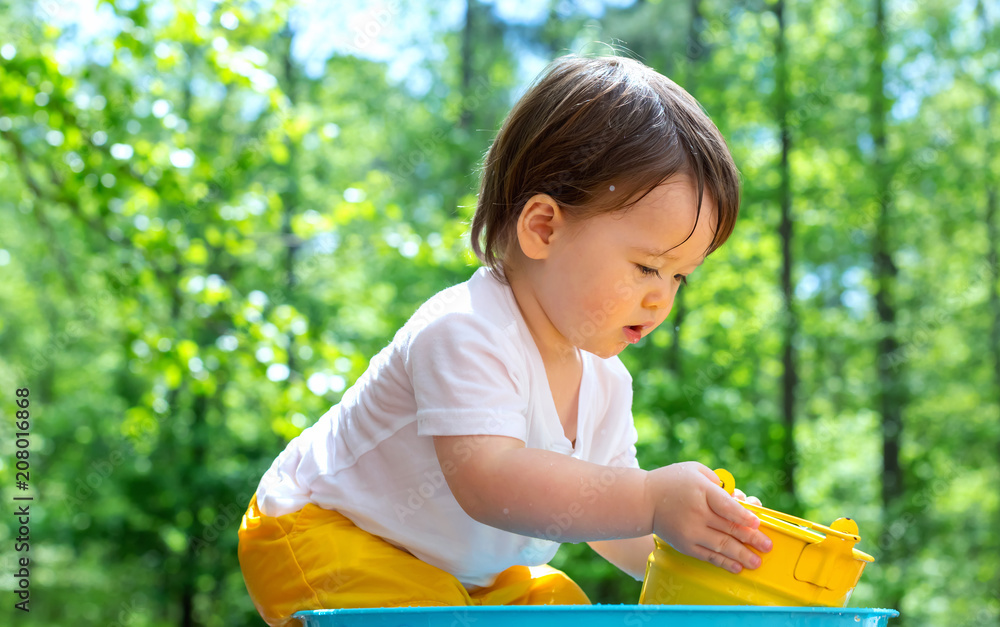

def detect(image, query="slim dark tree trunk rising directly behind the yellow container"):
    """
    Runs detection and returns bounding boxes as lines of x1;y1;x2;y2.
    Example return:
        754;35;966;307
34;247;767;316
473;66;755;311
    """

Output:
773;0;798;510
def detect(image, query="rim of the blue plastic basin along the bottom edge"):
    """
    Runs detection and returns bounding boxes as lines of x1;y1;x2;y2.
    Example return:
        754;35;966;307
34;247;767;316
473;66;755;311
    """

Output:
295;605;899;627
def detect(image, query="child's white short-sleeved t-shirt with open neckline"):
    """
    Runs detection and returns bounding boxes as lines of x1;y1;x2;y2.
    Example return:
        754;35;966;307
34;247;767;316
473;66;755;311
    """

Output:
257;268;638;586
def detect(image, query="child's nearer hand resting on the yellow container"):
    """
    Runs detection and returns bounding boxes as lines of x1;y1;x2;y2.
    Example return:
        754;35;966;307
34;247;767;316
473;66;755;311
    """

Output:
647;462;771;573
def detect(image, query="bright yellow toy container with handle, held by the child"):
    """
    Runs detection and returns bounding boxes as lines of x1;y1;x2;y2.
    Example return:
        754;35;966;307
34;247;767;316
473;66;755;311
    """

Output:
639;468;875;607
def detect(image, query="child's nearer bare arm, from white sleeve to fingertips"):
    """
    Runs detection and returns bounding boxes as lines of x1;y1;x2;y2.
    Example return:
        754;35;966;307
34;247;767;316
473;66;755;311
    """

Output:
434;435;770;572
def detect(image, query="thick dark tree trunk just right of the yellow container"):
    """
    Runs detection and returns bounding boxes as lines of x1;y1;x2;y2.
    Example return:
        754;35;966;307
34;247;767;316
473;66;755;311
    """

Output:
871;0;907;608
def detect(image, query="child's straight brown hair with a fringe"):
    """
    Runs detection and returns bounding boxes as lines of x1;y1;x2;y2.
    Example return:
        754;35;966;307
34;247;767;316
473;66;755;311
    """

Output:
471;55;740;279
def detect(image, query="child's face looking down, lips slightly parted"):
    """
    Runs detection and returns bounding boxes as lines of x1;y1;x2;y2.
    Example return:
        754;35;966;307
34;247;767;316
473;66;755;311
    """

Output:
536;176;717;357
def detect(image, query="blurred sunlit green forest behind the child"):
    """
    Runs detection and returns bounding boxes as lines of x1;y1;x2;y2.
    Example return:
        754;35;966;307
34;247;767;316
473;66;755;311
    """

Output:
0;0;1000;626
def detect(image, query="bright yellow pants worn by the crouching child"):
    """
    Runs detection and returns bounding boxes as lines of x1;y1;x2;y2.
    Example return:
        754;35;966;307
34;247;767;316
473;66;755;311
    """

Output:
239;494;590;627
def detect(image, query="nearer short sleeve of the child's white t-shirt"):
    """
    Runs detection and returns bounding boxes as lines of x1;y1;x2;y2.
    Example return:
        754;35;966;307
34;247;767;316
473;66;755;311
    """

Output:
406;314;528;441
